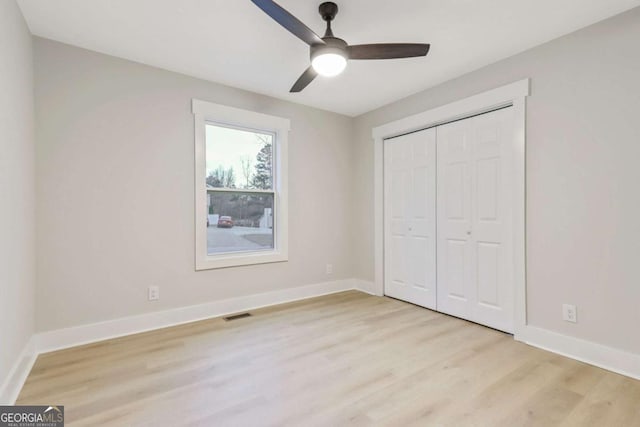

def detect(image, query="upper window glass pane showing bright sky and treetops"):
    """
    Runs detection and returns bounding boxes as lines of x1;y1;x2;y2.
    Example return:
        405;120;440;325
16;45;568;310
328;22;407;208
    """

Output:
206;123;273;190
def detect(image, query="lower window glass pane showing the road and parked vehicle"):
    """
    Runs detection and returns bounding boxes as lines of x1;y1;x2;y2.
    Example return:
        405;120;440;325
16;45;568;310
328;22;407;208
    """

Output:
207;190;273;255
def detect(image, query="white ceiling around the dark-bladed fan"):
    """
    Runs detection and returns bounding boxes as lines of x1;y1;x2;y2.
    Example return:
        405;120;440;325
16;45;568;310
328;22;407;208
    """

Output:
18;0;640;116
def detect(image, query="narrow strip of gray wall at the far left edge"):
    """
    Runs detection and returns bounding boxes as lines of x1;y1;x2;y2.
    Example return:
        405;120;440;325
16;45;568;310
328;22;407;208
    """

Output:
0;0;35;402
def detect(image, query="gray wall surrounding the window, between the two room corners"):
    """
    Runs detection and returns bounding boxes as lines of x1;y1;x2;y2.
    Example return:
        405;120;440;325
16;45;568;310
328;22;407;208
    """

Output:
35;38;354;331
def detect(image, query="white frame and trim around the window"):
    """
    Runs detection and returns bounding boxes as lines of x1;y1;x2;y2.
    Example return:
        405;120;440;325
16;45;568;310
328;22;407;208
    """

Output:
192;99;291;270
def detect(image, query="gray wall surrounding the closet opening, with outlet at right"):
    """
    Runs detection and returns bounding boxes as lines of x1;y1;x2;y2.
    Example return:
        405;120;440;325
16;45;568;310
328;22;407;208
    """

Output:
354;8;640;353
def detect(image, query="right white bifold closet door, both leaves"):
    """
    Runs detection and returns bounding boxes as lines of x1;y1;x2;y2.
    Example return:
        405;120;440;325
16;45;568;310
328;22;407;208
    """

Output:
437;108;514;332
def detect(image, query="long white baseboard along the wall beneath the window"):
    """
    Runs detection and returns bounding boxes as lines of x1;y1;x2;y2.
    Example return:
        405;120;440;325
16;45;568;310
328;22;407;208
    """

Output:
36;279;356;353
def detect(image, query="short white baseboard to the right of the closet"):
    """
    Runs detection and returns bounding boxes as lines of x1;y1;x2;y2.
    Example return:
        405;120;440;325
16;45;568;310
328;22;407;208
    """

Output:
516;325;640;379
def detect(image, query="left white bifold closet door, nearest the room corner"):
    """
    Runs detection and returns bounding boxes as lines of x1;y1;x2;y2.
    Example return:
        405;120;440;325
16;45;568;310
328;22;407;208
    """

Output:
384;129;436;309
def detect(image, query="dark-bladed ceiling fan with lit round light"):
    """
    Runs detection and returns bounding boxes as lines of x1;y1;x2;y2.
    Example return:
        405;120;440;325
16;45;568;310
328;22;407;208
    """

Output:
251;0;429;92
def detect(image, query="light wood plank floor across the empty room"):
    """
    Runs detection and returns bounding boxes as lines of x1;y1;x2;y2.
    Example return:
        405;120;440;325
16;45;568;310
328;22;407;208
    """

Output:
18;291;640;427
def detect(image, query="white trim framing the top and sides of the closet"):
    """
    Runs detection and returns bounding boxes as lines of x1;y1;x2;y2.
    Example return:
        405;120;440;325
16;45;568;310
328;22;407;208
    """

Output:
372;79;530;340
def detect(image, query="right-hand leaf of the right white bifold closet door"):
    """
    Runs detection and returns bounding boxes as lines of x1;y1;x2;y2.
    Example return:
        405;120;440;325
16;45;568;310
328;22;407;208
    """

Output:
472;108;514;332
